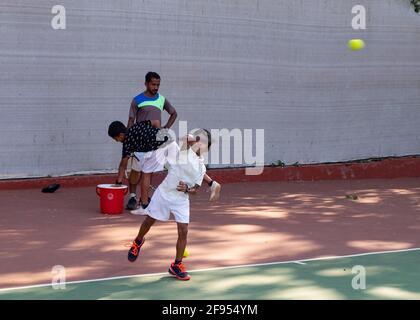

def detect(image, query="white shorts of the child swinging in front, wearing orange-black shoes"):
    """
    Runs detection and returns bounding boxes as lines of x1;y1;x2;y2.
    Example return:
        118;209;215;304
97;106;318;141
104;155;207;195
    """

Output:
145;188;190;223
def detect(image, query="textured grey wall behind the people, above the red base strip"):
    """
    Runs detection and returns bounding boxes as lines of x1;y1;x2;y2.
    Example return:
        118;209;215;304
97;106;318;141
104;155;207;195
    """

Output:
0;0;420;178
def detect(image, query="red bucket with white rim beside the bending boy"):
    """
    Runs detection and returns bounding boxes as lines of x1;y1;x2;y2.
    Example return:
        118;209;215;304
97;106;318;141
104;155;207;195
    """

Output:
96;184;128;214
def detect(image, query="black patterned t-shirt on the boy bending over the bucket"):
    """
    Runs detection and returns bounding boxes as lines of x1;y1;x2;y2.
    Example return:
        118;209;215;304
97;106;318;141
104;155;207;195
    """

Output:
122;121;171;158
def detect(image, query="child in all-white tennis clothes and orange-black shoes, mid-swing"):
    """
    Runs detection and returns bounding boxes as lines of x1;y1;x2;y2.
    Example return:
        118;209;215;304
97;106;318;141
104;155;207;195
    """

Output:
124;129;211;280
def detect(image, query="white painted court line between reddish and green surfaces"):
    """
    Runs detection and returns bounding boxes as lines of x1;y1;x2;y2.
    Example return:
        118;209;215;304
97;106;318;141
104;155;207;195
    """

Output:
0;248;420;293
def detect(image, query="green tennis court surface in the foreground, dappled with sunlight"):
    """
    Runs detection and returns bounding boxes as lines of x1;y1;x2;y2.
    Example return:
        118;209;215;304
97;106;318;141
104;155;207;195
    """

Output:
0;249;420;300
